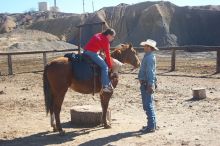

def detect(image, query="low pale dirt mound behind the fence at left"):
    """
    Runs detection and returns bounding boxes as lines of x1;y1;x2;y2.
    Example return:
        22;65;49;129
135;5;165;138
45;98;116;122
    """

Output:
0;29;76;52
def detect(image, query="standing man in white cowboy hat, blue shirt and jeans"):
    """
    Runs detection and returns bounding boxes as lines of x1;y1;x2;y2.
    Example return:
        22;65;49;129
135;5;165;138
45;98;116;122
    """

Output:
138;39;159;133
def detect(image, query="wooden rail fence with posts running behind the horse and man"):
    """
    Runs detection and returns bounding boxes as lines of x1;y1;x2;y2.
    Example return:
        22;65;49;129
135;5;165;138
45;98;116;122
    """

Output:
0;45;220;75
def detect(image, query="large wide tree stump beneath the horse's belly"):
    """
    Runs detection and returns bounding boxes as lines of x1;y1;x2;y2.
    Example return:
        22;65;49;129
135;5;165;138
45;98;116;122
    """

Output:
70;105;111;126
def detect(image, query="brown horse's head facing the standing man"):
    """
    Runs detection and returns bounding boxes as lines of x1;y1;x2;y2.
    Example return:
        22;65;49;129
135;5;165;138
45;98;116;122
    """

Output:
112;44;140;68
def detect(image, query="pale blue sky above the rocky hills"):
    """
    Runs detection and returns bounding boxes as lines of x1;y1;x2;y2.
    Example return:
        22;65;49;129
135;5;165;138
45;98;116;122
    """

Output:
0;0;220;14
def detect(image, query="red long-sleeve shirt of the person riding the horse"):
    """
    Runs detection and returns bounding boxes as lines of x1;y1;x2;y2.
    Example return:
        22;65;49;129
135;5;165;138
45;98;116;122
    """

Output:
84;33;112;68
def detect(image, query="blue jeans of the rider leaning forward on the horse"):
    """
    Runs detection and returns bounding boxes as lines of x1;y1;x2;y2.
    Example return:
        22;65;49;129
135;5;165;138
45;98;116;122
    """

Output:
84;51;110;86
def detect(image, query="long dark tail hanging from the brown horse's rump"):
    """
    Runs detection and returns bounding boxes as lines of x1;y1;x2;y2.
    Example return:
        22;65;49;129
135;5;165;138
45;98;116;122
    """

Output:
43;65;53;115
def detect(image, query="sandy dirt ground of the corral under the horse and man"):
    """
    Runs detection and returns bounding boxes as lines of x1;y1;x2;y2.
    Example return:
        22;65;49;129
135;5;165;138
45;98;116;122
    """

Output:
0;52;220;146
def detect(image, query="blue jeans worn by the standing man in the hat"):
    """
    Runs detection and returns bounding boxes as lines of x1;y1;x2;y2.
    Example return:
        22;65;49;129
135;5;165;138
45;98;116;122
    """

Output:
140;84;156;129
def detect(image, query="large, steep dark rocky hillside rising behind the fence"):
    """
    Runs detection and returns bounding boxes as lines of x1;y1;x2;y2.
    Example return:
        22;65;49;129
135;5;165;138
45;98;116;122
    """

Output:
0;1;220;46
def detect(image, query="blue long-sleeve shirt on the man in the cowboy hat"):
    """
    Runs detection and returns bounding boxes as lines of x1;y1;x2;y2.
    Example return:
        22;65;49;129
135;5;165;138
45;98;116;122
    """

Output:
138;52;157;86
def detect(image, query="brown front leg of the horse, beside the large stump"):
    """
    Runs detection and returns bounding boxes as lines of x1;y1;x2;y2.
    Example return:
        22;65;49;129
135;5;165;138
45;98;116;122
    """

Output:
100;93;111;129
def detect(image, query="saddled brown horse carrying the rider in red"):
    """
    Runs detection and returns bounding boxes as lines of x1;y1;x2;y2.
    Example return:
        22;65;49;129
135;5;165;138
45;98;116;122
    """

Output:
43;44;140;133
